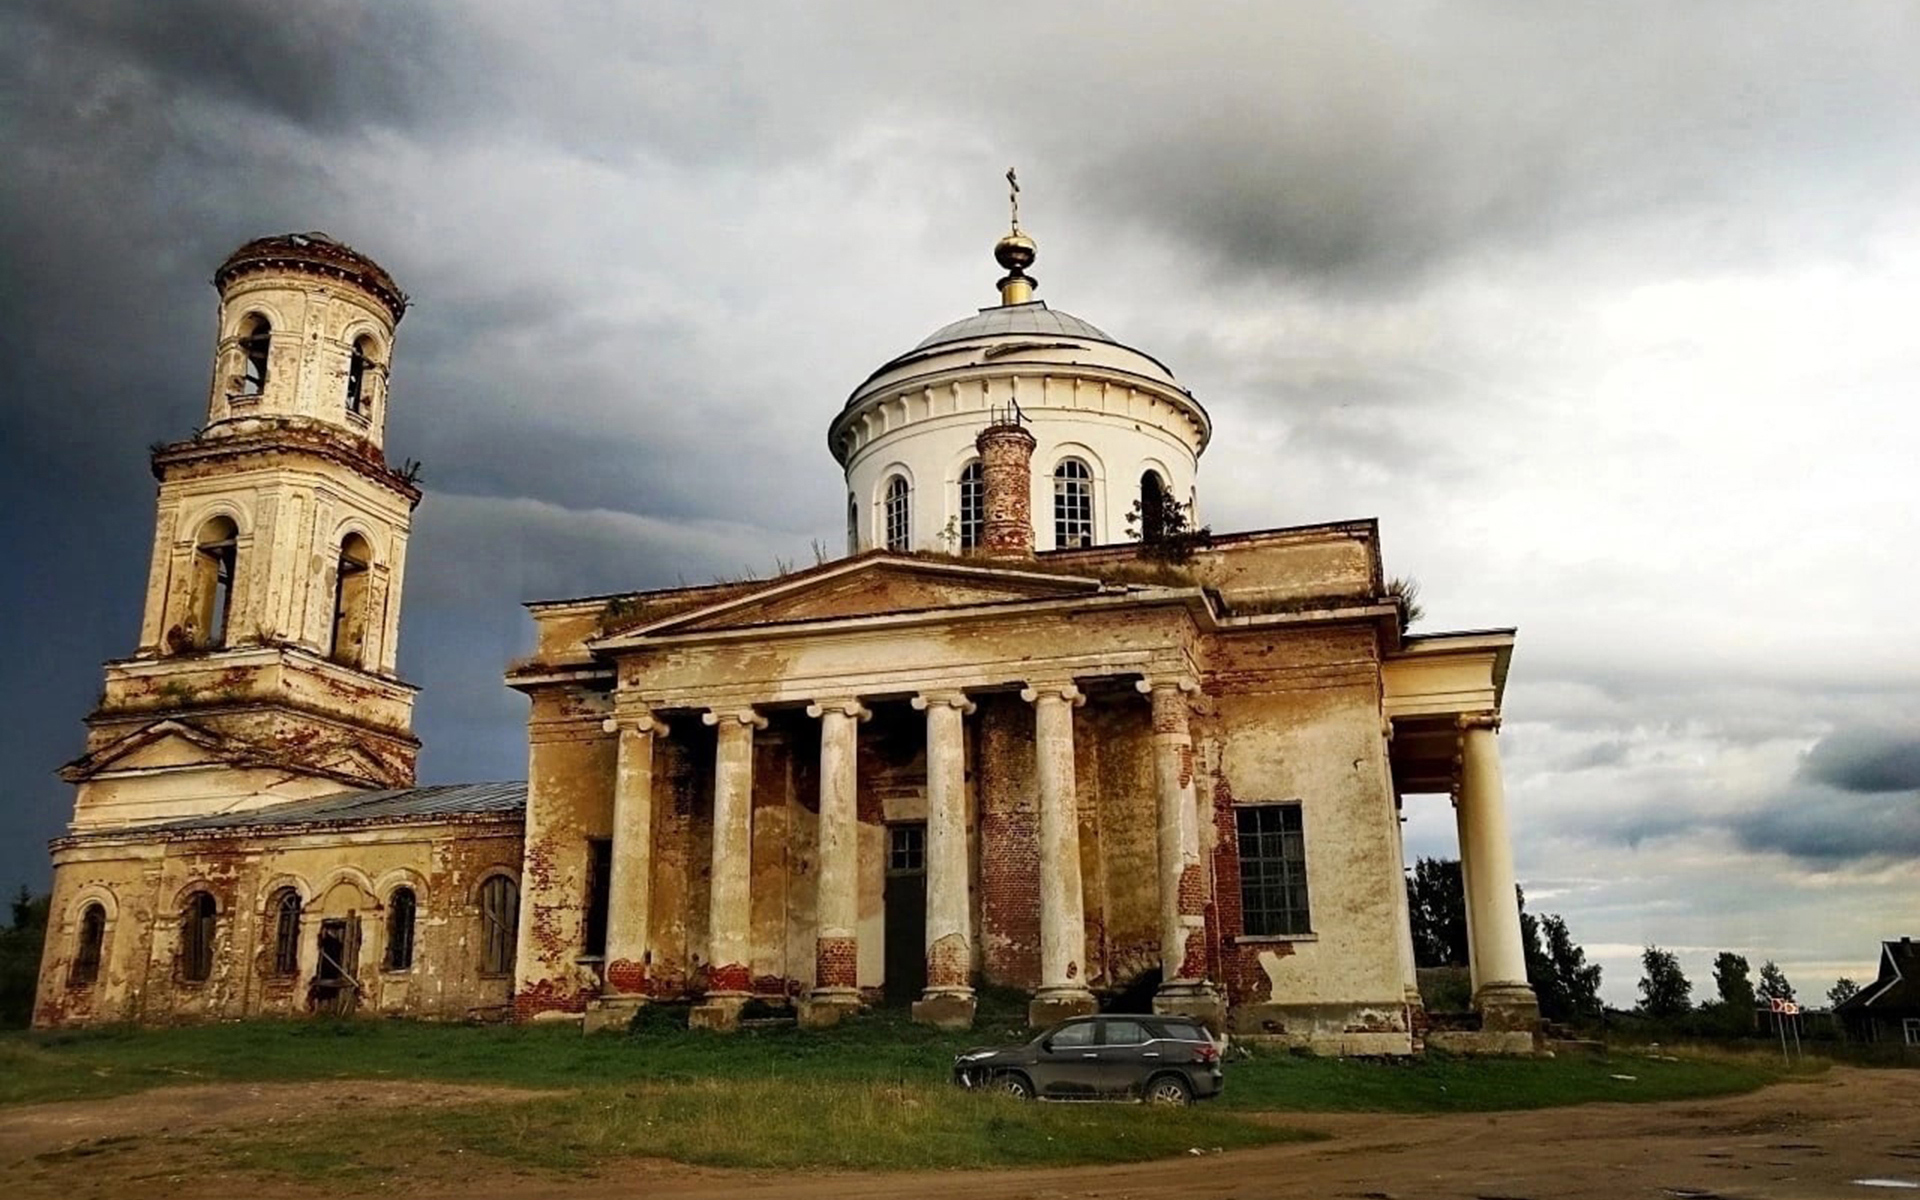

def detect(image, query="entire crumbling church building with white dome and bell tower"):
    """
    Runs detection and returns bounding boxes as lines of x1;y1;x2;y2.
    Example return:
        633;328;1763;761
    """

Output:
35;213;1538;1054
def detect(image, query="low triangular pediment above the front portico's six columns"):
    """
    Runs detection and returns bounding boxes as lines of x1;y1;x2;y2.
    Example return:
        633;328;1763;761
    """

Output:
607;555;1100;645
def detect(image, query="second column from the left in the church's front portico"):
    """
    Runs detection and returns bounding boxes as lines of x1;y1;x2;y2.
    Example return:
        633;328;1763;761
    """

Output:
687;708;766;1029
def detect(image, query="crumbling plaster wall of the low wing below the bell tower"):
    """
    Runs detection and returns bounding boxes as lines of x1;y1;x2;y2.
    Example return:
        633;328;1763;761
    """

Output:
35;820;520;1027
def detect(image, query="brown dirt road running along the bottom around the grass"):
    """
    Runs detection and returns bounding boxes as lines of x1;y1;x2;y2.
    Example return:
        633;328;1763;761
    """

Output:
0;1068;1920;1200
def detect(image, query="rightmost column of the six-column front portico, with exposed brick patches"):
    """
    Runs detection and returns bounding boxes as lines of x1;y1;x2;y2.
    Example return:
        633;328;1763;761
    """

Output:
1135;680;1227;1027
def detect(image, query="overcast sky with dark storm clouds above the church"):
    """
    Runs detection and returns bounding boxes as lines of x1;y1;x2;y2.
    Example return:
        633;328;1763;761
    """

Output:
0;0;1920;1002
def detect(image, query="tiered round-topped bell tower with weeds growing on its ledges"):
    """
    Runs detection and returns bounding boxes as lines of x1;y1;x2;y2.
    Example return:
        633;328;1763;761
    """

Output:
61;232;420;831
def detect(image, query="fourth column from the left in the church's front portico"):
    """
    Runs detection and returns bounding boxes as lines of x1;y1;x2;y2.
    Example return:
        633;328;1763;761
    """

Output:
914;691;973;1029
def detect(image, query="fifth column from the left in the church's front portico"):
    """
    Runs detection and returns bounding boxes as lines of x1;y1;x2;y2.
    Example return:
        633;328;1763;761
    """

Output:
1020;684;1098;1027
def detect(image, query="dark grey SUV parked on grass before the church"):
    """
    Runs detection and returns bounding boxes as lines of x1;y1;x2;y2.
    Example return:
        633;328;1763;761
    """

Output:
954;1014;1223;1104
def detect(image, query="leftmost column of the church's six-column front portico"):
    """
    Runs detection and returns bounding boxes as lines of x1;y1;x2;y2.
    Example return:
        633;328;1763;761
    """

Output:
603;708;660;996
